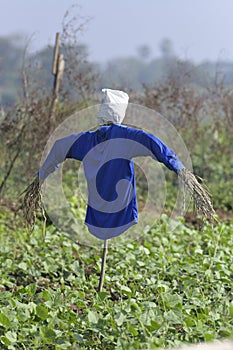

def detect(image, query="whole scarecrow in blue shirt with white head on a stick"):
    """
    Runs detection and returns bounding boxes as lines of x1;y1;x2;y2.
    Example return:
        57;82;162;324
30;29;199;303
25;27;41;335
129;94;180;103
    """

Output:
23;89;214;290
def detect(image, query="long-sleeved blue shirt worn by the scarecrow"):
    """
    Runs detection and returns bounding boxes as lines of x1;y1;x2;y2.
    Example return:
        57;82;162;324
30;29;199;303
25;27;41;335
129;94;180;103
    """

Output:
39;124;184;239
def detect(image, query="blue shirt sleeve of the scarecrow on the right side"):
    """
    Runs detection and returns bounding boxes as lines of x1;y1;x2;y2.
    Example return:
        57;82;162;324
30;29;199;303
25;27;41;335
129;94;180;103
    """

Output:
128;130;185;174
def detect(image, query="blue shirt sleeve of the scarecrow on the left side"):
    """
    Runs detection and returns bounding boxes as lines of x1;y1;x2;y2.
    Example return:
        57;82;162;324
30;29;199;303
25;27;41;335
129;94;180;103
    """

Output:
38;134;81;182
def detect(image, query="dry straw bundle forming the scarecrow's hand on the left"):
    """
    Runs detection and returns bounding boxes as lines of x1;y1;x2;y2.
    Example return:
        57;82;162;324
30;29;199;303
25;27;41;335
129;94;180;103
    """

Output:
22;176;45;232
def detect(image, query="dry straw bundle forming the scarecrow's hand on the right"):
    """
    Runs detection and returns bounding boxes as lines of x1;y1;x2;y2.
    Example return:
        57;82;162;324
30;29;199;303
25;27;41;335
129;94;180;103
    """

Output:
178;169;215;221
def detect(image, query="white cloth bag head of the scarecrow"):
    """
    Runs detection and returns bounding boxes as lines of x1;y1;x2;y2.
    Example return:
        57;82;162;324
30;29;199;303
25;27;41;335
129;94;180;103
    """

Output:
98;89;129;125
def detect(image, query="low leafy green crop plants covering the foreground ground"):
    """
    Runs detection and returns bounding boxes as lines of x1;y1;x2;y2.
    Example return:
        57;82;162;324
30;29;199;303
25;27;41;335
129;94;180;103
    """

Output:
0;214;233;350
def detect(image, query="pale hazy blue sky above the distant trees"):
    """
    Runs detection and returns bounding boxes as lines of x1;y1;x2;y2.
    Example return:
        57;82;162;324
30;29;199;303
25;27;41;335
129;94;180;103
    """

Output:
0;0;233;62
